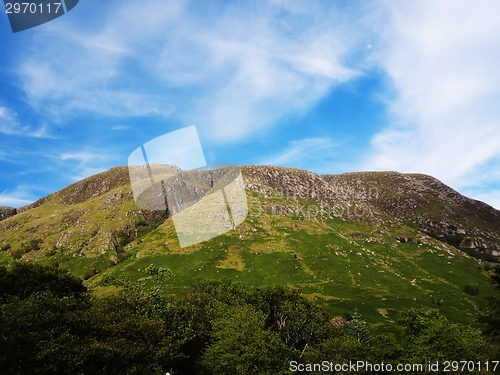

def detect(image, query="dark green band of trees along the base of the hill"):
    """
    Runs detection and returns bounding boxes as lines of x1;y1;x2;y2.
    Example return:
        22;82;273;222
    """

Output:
0;265;499;374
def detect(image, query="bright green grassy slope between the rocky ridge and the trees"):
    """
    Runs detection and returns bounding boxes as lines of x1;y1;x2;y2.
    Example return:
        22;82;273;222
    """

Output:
79;206;493;327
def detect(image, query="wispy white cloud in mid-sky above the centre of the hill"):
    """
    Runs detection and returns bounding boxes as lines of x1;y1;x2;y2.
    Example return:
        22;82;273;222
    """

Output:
175;3;357;141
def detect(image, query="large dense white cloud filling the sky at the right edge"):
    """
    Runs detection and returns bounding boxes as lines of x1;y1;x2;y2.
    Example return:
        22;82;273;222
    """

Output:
362;0;500;200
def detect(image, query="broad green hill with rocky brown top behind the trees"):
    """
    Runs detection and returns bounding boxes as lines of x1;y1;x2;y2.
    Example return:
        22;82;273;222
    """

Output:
0;166;500;324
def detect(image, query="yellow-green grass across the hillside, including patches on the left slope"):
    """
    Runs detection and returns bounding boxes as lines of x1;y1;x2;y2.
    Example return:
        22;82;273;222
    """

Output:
0;189;493;327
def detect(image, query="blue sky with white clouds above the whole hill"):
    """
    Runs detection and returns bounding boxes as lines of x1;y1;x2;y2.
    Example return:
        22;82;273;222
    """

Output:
0;0;500;209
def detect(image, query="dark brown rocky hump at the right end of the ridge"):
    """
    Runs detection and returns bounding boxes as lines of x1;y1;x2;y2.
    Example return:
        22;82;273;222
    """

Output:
323;172;500;256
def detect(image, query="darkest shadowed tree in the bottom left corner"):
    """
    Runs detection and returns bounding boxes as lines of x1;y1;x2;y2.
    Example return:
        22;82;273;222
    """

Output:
0;291;89;374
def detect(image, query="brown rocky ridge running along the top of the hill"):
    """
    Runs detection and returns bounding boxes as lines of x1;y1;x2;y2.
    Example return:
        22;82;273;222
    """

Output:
0;165;500;256
